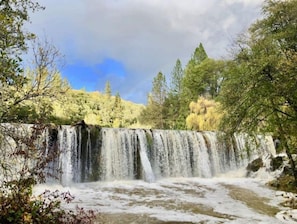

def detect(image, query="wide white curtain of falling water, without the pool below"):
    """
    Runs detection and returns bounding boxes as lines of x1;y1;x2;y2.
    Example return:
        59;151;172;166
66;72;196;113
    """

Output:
44;126;275;185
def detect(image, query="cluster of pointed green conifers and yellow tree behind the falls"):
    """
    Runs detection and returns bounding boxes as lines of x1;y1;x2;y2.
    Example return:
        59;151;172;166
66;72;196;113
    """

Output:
139;43;227;130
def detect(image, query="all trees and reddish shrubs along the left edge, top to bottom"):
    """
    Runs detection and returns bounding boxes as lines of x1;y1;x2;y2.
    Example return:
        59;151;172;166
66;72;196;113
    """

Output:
0;0;94;223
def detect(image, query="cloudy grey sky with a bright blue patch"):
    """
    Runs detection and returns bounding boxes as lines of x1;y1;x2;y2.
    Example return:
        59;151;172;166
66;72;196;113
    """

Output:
28;0;264;104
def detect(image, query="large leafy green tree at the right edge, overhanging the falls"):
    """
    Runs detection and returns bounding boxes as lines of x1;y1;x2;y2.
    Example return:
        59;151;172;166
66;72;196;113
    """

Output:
220;0;297;186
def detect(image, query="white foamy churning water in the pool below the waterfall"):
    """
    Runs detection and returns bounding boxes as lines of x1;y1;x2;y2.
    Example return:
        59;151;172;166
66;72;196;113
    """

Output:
34;177;290;224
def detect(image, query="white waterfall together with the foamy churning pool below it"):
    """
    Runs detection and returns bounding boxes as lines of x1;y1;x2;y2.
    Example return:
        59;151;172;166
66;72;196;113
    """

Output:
3;126;292;224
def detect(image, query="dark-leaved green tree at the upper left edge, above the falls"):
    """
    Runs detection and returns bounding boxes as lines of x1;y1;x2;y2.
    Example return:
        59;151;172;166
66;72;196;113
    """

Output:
0;0;41;122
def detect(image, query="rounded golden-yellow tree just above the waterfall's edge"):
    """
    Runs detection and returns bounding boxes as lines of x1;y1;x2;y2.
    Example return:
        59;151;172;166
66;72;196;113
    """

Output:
186;97;222;131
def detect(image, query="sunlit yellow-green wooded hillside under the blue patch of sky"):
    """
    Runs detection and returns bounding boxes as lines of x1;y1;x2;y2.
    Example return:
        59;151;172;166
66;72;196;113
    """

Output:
52;89;144;127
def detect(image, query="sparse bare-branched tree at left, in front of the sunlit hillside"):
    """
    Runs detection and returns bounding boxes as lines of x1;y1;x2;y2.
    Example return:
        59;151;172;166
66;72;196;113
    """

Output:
0;39;69;123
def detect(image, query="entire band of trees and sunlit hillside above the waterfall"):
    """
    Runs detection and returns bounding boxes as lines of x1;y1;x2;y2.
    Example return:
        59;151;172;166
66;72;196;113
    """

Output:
0;0;297;223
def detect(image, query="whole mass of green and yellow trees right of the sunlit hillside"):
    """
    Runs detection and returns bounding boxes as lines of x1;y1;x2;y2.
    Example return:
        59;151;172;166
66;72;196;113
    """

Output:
140;0;297;191
